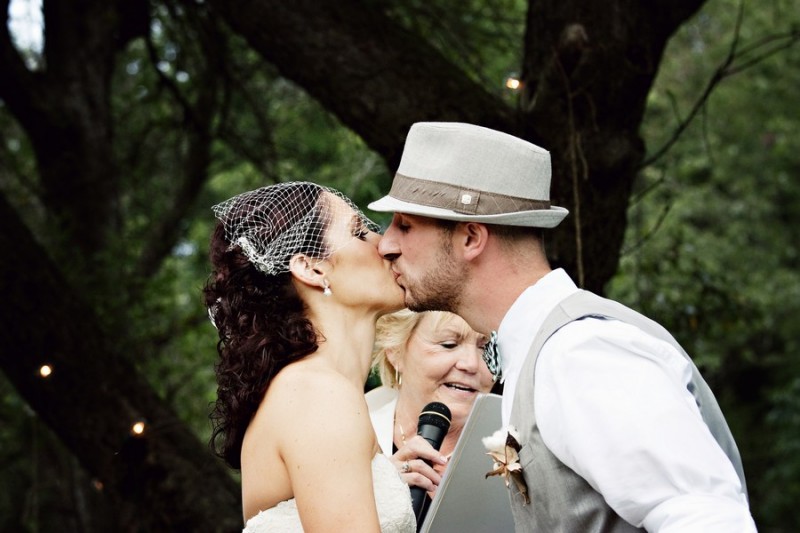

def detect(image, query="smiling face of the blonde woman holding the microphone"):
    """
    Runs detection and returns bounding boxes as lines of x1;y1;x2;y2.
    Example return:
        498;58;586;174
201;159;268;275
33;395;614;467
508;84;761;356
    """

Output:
400;313;493;428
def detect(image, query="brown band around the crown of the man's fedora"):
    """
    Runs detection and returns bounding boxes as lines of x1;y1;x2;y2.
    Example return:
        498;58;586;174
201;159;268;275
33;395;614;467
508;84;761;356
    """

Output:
389;174;550;215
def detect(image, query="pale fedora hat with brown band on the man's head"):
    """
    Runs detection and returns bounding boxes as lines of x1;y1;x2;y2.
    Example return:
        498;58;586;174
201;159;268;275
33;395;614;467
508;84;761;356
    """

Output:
369;122;569;228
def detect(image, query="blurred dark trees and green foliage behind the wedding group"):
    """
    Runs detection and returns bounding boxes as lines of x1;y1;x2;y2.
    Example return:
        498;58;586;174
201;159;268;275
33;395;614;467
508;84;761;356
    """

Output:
0;0;800;532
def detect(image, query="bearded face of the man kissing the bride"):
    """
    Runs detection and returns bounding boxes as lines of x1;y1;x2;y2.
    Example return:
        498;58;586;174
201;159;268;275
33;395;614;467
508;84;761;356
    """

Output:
378;213;466;313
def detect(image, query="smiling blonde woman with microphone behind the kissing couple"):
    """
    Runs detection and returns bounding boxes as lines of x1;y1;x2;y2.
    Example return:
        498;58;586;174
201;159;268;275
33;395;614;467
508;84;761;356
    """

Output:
367;309;494;512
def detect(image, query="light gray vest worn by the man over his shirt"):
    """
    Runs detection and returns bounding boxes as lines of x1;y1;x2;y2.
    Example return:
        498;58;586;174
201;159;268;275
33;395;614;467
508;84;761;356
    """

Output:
510;291;747;533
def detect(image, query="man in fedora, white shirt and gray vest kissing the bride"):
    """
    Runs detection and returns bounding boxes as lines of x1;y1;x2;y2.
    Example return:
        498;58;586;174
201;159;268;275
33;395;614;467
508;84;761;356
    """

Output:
369;123;755;532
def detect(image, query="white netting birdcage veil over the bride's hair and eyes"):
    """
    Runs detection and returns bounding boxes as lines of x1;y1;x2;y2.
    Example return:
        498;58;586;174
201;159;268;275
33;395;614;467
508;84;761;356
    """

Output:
211;181;379;275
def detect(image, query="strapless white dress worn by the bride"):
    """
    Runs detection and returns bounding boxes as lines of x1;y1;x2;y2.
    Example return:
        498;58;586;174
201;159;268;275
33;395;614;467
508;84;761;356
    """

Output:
243;453;417;533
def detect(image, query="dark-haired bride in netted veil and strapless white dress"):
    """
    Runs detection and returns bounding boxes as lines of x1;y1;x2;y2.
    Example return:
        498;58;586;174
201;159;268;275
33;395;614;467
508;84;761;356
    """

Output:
204;182;416;533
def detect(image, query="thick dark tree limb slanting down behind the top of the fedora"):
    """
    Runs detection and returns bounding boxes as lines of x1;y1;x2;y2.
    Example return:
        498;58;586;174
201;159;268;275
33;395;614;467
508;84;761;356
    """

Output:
210;0;514;167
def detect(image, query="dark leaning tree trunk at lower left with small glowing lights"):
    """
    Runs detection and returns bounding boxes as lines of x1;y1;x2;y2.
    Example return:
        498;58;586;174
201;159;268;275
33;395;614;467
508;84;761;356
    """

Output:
0;192;242;531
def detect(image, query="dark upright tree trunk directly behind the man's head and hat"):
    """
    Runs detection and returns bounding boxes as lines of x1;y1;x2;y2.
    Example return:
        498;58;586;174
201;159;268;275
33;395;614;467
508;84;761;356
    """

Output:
520;0;704;293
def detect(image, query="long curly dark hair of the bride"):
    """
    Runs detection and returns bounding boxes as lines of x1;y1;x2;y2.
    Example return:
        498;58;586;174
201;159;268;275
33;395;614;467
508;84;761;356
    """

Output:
203;184;327;469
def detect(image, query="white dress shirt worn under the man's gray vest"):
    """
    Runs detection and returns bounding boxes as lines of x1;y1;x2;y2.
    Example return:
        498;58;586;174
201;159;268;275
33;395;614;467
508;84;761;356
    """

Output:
497;269;756;533
